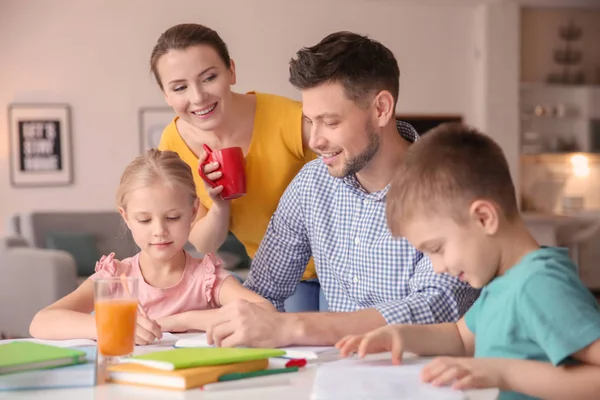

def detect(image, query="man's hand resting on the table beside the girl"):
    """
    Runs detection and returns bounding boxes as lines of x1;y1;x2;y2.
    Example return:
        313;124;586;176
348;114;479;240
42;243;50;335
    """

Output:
206;300;291;348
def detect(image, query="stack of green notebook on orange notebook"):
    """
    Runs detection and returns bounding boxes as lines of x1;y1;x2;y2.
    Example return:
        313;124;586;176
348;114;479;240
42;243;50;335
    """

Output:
107;347;290;390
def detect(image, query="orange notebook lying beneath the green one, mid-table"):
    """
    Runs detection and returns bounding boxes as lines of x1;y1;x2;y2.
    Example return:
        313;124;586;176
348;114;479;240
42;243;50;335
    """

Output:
108;358;269;390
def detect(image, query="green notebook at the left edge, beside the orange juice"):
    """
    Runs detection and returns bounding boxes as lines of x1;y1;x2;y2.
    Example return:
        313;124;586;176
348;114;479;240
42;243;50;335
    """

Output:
0;341;86;374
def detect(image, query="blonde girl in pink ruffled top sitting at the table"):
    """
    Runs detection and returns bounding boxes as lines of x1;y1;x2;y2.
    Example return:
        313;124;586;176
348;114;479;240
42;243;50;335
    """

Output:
29;150;273;344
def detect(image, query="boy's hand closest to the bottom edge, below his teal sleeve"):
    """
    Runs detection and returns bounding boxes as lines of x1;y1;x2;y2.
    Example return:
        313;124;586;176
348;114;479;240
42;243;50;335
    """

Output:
421;357;510;390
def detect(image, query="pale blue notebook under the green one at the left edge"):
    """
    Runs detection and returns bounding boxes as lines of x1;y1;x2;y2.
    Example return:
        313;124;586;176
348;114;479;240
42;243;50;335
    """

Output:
0;347;96;391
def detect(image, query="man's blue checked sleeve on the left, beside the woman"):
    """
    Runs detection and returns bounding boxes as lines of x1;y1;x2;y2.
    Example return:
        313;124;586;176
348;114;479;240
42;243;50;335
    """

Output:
244;168;311;311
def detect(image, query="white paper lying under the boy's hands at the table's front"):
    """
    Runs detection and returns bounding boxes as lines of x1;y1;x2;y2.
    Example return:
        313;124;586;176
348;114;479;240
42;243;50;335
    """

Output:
311;359;466;400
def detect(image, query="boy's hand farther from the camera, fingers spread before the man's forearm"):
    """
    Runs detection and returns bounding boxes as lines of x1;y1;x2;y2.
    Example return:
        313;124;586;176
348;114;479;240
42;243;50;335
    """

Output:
335;325;404;364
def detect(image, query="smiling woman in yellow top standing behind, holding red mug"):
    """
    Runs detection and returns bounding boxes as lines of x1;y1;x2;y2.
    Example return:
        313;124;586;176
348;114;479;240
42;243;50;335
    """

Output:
150;24;326;311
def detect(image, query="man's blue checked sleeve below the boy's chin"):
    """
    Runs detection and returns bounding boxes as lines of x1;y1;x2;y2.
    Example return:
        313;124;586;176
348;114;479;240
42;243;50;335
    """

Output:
375;253;479;324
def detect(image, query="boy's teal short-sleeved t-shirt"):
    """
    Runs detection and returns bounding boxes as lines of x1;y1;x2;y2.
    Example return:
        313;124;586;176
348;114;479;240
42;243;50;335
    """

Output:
465;247;600;400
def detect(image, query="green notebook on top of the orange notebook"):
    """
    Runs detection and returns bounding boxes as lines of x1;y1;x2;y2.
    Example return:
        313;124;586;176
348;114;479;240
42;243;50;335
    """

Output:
121;347;285;371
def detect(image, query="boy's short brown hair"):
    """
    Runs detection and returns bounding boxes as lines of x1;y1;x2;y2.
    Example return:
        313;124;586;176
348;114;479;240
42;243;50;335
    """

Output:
386;123;519;236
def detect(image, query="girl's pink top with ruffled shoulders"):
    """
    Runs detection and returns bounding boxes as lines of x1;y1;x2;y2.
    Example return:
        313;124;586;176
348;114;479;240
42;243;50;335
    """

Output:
90;252;229;320
